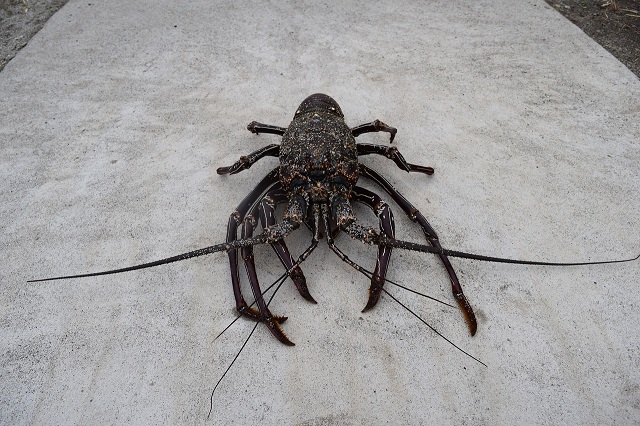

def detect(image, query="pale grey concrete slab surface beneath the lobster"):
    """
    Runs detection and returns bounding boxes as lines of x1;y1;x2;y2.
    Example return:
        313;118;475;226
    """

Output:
0;0;640;425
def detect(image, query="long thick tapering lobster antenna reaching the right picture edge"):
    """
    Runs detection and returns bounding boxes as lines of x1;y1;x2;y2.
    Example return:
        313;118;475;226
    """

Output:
375;234;640;266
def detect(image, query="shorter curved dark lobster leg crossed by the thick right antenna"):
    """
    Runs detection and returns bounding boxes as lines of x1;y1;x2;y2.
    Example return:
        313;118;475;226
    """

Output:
353;186;396;312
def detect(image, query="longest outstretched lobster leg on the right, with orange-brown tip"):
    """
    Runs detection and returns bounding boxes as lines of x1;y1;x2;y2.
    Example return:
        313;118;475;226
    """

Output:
359;164;478;336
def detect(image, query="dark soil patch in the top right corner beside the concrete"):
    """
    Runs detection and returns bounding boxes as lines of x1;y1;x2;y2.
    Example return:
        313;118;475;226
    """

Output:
545;0;640;77
